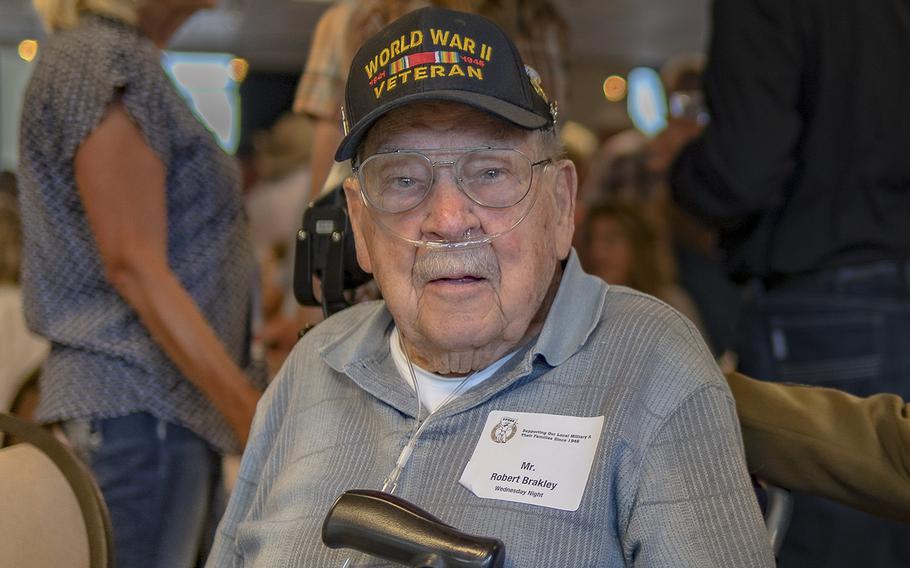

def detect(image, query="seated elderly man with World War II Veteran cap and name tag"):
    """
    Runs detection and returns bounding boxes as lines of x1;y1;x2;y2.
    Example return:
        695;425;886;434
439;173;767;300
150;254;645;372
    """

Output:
209;8;773;567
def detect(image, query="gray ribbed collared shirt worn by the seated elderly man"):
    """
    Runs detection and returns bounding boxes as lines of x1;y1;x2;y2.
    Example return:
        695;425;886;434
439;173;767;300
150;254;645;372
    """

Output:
208;252;773;568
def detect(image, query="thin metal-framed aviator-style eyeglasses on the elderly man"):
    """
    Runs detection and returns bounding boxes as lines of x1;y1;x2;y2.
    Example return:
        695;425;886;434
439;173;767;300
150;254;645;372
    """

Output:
353;147;552;213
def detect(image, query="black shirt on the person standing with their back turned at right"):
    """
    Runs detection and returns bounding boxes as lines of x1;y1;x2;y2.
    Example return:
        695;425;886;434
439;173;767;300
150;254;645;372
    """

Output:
671;0;910;280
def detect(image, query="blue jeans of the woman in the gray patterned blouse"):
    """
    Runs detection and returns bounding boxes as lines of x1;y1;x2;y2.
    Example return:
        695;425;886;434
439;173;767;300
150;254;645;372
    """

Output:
63;413;224;568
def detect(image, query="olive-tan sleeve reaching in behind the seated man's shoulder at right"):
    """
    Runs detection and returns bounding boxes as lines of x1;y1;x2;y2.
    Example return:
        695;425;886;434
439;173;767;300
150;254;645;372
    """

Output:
726;373;910;521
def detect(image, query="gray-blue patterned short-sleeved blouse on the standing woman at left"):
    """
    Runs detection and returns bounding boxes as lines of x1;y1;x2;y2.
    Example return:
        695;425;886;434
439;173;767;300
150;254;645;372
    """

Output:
19;16;263;450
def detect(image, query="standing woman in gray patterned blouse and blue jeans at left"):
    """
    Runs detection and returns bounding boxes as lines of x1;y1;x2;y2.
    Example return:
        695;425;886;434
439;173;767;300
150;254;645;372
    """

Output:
19;0;262;568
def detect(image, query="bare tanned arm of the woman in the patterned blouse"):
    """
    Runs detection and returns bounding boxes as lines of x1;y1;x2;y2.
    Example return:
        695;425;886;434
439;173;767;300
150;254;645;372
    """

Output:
74;103;260;443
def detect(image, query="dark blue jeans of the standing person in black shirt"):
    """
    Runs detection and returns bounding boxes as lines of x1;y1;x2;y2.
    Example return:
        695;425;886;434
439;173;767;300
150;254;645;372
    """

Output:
739;262;910;568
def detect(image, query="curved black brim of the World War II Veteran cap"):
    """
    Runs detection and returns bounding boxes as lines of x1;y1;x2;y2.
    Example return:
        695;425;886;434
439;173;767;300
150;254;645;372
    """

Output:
335;90;549;162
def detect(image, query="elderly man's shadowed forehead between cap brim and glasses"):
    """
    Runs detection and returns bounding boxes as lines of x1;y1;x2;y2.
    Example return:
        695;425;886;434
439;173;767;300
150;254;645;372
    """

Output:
357;102;534;158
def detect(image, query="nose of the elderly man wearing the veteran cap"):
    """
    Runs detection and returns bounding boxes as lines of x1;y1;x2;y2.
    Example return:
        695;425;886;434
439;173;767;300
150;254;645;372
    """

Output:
421;167;480;241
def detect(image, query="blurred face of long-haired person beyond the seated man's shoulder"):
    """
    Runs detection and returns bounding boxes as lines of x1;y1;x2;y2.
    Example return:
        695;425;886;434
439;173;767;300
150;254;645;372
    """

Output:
585;215;634;286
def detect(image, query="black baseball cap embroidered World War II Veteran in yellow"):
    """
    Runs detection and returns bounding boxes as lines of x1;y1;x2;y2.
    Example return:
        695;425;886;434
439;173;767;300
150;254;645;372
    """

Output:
335;7;556;161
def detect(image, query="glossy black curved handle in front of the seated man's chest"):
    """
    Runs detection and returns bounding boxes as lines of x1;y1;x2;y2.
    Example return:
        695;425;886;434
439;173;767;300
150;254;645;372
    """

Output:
322;489;505;568
